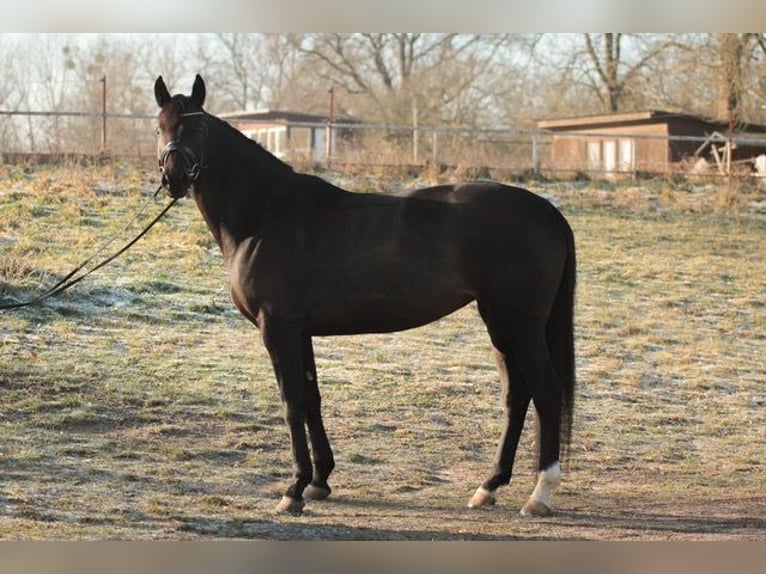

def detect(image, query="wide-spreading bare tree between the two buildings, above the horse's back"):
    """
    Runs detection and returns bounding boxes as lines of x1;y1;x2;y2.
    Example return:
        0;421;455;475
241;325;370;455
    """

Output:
292;33;513;123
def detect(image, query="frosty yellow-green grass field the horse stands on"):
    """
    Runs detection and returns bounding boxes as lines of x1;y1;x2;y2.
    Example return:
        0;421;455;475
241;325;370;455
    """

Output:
0;164;766;540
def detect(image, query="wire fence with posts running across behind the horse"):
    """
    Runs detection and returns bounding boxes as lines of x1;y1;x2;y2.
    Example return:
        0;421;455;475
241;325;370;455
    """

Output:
0;107;766;179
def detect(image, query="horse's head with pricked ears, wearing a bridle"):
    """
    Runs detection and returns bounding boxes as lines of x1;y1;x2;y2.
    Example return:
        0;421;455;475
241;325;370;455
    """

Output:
154;75;207;197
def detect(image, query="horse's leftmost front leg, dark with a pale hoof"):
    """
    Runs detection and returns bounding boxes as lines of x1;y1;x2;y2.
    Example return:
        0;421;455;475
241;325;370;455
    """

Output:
261;317;312;515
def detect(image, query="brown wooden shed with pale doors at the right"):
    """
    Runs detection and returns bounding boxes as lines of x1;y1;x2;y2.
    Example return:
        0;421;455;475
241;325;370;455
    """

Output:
537;110;766;177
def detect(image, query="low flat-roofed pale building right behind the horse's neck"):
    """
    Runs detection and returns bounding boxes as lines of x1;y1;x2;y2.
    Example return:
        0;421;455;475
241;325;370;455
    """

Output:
219;109;357;161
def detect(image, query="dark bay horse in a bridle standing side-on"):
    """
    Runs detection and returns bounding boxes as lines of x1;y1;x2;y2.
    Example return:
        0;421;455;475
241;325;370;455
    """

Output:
154;76;575;516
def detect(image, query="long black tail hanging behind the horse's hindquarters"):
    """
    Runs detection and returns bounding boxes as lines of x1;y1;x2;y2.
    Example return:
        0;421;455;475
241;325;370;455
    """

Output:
546;216;577;466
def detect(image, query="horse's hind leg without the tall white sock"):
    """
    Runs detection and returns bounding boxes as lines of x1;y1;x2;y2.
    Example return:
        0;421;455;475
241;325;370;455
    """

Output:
468;348;531;508
